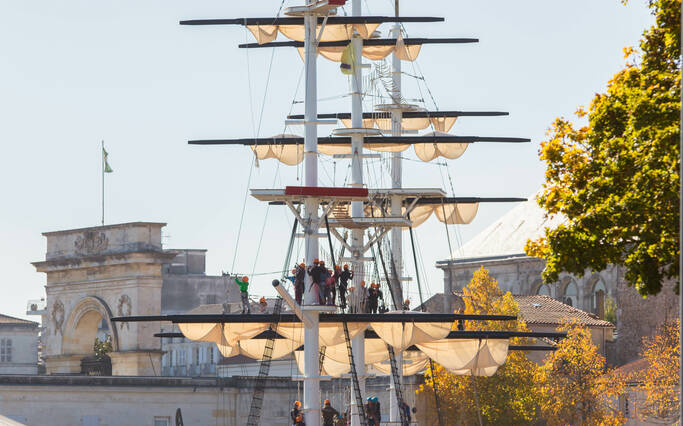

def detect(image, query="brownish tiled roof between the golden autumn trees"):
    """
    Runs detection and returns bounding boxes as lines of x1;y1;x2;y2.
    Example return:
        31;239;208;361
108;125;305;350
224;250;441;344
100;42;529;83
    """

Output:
514;294;614;328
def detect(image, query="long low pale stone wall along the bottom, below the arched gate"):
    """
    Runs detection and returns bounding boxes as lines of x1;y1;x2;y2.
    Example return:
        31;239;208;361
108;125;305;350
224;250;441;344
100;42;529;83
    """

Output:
0;376;400;426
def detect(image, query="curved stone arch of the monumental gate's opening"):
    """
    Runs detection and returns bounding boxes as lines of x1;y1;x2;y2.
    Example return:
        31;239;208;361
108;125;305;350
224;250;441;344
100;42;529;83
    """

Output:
62;296;119;356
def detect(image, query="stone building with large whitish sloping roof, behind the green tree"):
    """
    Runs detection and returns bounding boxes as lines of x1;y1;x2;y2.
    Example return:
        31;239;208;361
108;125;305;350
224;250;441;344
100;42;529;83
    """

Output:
436;193;679;365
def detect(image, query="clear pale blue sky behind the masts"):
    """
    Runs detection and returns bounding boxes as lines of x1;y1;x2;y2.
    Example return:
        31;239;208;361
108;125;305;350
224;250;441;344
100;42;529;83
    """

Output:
0;0;652;319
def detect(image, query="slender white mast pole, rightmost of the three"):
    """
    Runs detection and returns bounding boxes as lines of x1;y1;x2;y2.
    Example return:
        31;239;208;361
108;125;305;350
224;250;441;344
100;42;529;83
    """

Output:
387;0;403;423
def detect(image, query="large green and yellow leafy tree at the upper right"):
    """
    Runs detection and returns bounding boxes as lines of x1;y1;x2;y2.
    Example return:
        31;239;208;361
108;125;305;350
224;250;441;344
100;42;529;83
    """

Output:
526;0;681;295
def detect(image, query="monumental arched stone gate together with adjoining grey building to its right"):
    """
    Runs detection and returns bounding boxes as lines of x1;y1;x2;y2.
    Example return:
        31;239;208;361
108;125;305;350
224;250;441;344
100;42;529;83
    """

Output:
27;222;239;376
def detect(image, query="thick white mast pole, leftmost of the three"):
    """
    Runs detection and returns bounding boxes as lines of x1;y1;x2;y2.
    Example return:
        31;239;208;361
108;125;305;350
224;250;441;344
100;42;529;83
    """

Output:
303;13;320;426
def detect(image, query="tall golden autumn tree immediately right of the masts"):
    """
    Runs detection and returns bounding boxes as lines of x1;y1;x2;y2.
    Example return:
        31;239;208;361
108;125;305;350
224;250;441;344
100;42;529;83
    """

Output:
418;268;538;425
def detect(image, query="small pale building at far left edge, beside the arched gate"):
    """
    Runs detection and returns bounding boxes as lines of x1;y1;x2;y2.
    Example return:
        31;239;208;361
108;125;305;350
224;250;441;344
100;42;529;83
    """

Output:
0;314;40;374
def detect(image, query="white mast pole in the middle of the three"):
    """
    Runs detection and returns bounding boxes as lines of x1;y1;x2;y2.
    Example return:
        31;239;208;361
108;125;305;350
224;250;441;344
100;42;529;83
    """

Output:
351;0;365;426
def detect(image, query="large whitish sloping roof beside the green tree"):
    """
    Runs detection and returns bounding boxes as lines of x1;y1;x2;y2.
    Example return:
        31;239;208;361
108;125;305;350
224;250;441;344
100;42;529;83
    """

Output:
453;190;565;259
